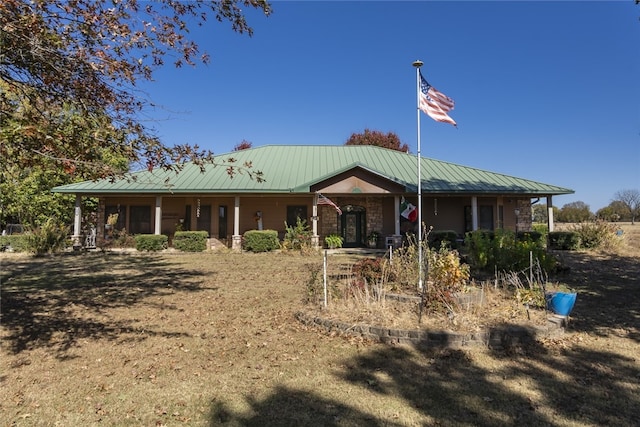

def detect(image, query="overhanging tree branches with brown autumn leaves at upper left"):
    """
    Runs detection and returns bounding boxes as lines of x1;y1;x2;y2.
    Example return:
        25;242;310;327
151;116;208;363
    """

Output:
0;0;271;178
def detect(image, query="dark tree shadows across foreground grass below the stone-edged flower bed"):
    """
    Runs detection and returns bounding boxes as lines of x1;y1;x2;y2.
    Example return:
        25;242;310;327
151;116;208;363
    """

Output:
209;334;640;426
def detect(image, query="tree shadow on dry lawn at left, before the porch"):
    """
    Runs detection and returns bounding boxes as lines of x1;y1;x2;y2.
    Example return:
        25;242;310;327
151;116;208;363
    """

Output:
1;253;210;359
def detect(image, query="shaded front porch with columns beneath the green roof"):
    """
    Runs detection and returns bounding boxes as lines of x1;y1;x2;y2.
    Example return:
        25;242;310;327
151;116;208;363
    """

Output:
73;194;553;250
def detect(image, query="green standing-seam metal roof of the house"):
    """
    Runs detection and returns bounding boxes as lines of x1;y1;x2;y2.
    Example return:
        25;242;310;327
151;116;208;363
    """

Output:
52;145;573;196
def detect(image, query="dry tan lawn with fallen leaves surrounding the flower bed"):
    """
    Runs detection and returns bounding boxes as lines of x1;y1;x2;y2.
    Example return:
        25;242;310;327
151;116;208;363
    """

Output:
0;225;640;426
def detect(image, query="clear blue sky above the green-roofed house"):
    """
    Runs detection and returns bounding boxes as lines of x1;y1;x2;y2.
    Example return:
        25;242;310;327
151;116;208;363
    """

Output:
138;0;640;212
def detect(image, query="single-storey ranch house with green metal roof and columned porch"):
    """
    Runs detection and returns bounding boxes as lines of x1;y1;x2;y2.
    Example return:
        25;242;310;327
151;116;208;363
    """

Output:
52;145;573;249
